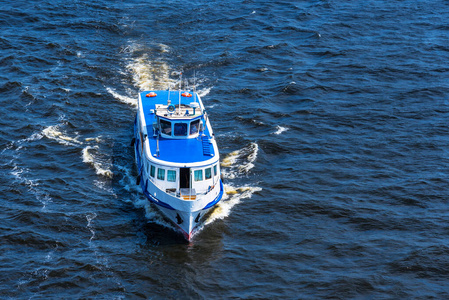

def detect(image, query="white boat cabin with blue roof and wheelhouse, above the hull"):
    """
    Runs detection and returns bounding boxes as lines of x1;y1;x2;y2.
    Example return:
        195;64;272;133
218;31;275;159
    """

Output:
139;91;220;200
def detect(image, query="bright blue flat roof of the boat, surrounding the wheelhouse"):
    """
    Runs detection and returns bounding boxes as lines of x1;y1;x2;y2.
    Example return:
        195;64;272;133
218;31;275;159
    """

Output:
140;91;218;163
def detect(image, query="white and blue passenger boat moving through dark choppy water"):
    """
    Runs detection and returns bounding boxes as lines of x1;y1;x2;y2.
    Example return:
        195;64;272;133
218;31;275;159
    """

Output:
133;90;224;241
